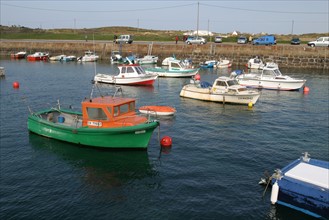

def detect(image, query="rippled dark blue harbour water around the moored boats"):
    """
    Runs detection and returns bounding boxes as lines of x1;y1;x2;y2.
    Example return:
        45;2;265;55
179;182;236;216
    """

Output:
0;59;329;219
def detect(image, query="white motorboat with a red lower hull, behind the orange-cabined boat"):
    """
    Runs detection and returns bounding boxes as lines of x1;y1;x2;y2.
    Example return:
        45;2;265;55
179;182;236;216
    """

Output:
94;58;158;85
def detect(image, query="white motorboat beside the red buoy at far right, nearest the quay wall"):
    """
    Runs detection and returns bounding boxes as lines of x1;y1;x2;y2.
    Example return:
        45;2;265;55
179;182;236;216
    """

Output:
231;63;306;90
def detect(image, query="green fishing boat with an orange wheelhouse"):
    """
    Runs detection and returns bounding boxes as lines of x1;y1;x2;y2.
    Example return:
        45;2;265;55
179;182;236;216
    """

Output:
27;93;159;149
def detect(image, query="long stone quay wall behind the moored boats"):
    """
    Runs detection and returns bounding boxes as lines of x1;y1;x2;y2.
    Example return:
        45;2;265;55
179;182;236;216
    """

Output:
0;40;329;70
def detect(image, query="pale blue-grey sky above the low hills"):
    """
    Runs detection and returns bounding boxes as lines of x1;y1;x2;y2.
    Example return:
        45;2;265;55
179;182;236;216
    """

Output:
0;0;329;35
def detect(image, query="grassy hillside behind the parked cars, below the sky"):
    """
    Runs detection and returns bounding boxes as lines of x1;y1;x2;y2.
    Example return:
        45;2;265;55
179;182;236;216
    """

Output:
0;26;327;43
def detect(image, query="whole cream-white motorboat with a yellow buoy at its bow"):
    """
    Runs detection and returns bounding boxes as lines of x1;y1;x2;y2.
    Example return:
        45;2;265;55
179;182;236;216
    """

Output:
180;76;260;105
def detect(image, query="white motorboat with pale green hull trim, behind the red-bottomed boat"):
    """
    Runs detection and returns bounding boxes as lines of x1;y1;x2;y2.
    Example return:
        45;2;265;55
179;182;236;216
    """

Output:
145;60;199;77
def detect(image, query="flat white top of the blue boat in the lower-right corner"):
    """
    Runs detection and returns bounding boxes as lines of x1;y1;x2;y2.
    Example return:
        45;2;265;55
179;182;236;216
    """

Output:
285;163;329;189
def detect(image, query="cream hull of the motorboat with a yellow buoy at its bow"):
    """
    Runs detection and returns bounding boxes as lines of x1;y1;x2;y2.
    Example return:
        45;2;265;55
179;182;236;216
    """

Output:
180;84;260;104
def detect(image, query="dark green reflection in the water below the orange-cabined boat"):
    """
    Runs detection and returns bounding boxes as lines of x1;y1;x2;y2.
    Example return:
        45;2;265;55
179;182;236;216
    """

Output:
29;133;155;189
